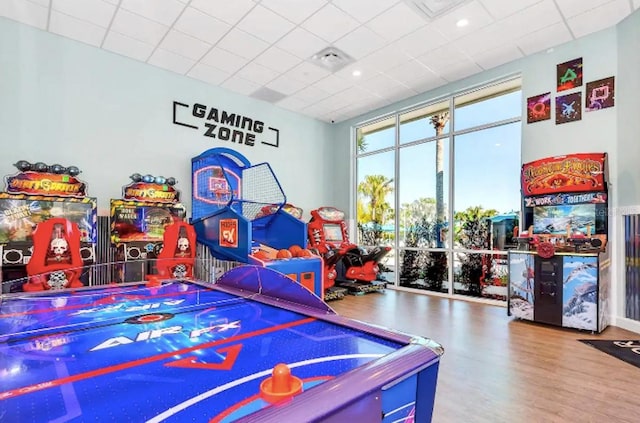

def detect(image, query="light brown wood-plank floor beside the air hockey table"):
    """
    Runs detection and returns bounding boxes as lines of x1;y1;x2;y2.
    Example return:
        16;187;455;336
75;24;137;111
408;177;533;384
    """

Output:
329;289;640;423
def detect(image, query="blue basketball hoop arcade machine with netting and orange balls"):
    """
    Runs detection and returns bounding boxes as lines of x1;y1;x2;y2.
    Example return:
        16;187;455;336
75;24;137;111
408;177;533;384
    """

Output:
191;148;324;298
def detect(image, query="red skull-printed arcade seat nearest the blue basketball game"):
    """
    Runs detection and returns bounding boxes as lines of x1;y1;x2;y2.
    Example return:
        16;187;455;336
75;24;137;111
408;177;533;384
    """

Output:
157;222;196;279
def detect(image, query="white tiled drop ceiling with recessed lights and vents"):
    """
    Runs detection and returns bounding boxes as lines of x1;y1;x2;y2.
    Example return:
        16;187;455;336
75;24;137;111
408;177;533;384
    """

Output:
0;0;640;122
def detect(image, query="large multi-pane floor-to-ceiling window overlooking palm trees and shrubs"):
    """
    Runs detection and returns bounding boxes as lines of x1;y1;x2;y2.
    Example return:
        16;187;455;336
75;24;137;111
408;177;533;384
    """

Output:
354;79;522;300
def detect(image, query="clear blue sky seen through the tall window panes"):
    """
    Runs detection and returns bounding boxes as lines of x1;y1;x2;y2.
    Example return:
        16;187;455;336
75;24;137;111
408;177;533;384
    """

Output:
358;91;522;219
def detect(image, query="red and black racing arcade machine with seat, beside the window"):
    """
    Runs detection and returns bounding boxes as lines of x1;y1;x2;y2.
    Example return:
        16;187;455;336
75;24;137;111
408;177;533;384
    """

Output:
308;207;391;293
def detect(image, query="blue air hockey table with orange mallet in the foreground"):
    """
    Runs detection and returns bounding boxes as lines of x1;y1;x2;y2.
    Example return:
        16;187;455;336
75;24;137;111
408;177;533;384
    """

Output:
0;266;443;423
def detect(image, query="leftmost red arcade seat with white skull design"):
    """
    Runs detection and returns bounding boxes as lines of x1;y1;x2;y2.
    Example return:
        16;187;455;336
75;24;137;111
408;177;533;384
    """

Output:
22;217;83;291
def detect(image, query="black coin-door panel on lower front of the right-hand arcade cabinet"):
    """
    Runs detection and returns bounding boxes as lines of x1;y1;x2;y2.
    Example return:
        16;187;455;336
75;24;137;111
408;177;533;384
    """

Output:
533;256;562;326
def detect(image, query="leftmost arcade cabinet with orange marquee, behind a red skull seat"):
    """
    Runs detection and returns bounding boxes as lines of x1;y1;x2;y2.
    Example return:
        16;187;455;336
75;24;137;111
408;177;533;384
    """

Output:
0;160;97;292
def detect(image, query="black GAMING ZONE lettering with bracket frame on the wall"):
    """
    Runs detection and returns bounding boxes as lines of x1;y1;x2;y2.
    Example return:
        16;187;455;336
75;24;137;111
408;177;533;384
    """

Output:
173;101;280;148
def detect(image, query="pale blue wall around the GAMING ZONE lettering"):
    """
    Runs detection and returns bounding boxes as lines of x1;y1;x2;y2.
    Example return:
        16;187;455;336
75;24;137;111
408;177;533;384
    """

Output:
0;18;334;215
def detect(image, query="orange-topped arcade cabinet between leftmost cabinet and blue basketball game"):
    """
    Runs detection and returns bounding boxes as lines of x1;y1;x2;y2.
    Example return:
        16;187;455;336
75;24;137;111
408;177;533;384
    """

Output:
111;173;186;282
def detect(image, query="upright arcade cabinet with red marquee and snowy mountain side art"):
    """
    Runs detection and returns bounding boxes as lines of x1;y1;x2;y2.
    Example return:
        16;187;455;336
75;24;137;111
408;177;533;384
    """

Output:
507;153;611;332
